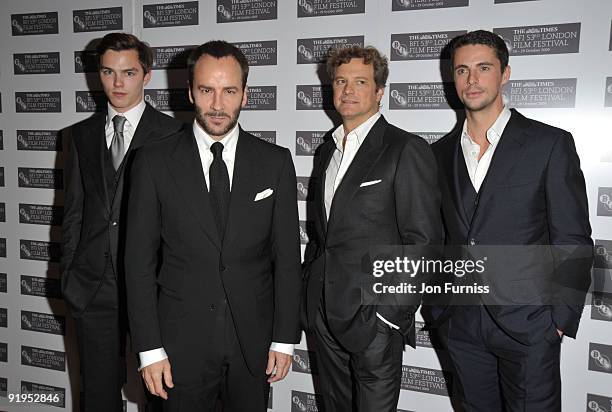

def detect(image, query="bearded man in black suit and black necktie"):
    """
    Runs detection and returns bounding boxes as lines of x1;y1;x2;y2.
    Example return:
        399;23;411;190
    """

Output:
126;41;301;412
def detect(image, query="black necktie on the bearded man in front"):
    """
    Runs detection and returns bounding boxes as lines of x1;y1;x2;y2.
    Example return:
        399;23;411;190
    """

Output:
208;142;230;240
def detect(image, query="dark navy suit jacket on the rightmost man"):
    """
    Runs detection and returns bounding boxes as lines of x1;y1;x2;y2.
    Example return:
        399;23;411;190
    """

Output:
433;109;593;344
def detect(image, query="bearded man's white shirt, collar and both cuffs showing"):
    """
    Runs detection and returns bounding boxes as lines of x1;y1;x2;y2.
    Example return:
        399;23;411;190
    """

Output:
139;121;294;369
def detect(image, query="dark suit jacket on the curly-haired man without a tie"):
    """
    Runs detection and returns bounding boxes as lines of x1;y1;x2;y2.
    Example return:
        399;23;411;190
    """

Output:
305;116;442;351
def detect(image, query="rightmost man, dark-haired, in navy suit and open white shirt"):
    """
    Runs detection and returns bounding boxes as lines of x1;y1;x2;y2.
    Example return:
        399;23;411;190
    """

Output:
433;30;592;412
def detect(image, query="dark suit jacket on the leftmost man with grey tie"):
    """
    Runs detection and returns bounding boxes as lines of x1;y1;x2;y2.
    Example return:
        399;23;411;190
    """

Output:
61;104;182;316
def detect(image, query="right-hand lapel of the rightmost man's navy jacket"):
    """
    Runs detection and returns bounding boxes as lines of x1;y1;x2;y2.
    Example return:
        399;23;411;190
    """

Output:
472;110;527;223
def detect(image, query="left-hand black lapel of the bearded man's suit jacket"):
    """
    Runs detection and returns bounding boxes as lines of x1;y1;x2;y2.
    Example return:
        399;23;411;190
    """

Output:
168;129;221;250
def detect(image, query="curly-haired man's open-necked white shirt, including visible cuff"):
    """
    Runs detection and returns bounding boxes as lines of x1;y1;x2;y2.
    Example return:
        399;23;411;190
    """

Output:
325;112;399;329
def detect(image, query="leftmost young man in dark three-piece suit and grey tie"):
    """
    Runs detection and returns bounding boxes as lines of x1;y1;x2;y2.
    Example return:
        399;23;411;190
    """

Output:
61;33;181;412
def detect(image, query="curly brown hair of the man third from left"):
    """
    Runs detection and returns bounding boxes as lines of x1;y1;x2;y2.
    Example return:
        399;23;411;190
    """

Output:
326;46;389;88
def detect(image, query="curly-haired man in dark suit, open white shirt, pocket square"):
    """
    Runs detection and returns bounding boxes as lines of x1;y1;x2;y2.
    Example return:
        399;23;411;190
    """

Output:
305;47;442;412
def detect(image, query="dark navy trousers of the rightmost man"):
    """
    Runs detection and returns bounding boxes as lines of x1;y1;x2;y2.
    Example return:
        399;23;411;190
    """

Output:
446;306;561;412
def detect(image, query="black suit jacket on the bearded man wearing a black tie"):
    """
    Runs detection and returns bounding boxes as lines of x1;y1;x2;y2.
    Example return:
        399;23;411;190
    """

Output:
126;129;301;376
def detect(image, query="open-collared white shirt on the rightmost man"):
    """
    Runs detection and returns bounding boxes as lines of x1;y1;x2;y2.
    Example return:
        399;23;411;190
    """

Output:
461;106;511;193
